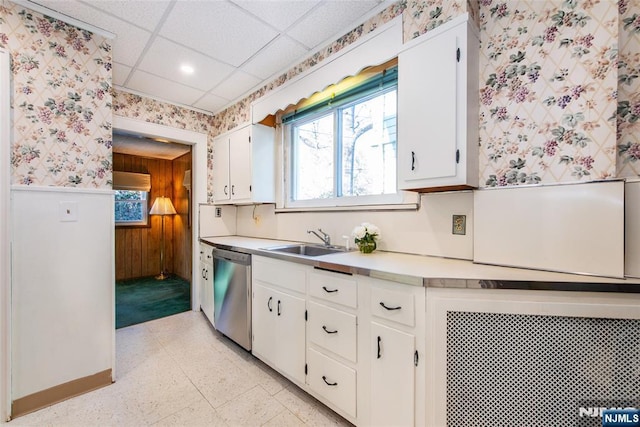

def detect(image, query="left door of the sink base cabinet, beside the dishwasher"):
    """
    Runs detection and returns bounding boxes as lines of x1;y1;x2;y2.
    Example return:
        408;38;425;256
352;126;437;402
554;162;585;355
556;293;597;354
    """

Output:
251;282;276;365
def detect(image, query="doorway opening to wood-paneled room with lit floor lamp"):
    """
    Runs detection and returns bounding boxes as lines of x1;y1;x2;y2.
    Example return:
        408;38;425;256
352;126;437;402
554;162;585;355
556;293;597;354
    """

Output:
113;130;193;329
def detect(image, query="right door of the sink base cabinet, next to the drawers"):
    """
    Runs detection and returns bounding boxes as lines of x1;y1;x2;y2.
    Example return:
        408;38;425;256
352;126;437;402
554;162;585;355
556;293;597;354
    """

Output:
274;292;305;383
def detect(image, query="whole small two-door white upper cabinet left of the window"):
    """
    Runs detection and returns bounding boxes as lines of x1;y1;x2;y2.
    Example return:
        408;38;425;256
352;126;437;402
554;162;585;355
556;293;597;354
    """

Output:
213;125;275;204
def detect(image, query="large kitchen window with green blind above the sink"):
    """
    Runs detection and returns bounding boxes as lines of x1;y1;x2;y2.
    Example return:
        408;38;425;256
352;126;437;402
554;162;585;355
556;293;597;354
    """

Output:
282;63;402;208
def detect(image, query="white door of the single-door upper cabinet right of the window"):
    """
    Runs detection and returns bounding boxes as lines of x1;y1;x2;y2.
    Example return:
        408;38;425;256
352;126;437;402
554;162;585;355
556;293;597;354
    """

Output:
398;25;457;185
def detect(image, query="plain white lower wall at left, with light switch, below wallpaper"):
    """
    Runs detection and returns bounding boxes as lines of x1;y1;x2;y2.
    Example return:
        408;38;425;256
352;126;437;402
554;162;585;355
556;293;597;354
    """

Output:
11;187;115;400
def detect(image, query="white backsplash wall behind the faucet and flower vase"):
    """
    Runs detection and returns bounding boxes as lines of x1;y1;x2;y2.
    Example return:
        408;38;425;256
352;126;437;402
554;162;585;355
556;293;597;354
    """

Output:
237;191;473;260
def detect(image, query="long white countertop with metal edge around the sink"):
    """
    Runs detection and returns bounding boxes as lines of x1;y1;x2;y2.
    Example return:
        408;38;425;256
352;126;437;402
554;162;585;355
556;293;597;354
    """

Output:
200;236;640;285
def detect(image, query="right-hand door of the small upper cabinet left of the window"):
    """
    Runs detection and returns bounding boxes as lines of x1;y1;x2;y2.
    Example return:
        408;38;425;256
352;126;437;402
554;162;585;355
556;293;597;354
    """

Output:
229;126;253;201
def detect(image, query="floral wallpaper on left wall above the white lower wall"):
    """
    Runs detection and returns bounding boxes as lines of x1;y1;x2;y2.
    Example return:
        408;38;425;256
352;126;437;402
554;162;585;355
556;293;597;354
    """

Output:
0;1;112;188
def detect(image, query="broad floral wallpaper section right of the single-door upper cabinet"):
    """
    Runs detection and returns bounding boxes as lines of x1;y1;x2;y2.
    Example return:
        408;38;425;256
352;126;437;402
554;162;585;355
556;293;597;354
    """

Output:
480;0;618;187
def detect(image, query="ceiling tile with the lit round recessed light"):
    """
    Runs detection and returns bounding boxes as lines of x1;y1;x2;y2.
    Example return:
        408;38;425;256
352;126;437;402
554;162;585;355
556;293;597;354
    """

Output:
138;37;233;91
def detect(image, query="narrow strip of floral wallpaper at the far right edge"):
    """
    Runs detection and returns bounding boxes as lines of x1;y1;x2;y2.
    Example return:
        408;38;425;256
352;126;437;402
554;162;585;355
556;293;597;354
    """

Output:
617;0;640;177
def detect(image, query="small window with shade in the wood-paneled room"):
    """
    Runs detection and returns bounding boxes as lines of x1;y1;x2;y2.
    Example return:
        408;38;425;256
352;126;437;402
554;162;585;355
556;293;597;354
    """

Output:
113;171;151;226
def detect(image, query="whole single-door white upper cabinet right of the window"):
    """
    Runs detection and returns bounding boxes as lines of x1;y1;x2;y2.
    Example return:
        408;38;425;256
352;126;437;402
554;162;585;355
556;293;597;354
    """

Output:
398;15;479;192
